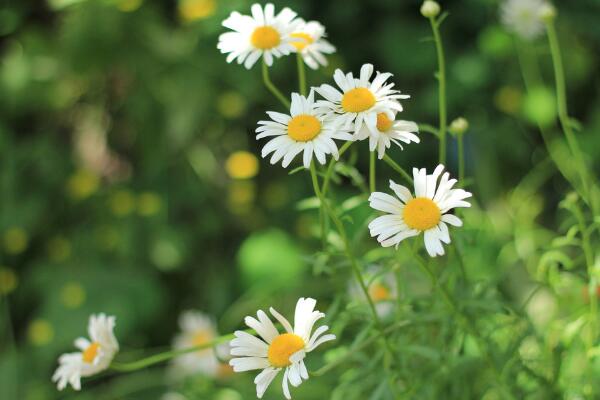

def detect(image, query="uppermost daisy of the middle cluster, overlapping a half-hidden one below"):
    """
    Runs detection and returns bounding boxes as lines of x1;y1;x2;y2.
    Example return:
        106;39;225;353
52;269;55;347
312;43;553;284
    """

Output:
315;64;410;134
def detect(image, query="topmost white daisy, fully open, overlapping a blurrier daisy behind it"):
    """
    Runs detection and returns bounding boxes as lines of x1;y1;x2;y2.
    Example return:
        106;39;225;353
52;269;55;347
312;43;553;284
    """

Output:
217;3;299;69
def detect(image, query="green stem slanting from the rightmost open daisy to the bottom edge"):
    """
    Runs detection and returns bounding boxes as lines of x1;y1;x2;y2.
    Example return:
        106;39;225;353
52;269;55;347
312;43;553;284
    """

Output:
406;245;514;399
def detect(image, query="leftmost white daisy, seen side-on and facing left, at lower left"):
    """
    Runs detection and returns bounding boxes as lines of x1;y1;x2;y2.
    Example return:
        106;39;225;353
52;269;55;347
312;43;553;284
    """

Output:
52;314;119;390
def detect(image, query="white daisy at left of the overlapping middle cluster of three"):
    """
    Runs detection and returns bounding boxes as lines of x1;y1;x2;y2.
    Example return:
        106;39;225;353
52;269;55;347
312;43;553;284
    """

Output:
256;90;353;168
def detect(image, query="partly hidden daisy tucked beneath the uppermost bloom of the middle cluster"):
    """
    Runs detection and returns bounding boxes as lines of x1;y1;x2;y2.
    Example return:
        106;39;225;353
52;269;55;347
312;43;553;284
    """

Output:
356;112;420;159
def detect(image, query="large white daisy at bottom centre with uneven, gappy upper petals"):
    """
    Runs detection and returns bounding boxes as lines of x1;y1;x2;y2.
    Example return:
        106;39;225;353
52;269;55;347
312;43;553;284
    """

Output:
229;298;335;399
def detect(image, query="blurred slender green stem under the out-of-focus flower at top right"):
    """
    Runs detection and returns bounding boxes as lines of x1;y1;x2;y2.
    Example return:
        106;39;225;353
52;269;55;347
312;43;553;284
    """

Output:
546;20;597;215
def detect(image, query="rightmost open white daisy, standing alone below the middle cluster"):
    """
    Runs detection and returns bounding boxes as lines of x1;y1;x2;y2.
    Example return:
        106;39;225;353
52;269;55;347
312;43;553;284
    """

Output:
369;165;471;257
